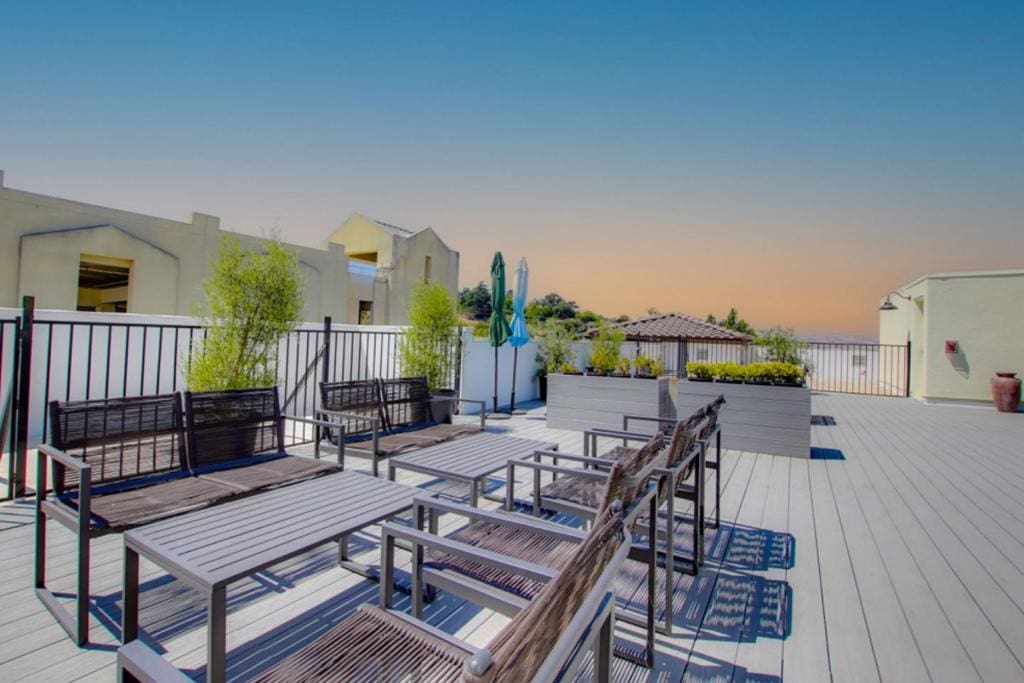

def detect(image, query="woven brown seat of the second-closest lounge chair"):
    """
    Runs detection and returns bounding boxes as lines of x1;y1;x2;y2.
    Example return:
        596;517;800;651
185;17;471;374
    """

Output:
424;521;580;599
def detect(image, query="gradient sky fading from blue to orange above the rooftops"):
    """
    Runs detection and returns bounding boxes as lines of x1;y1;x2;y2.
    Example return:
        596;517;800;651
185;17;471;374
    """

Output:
0;0;1024;336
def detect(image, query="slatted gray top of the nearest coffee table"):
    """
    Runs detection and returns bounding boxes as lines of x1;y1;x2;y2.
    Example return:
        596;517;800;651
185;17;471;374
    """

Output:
124;471;423;591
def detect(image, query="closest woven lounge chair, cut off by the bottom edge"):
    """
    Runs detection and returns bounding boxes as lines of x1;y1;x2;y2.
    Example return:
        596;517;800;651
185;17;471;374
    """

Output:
250;506;630;683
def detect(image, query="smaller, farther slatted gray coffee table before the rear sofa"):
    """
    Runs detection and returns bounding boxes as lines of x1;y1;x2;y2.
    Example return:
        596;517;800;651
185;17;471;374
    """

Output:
387;432;558;507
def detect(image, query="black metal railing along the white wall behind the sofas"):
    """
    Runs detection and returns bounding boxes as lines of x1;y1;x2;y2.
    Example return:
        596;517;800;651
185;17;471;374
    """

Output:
0;301;436;497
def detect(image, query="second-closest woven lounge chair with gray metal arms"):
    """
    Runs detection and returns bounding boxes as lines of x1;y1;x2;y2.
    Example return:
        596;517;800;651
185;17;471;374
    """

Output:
395;434;664;667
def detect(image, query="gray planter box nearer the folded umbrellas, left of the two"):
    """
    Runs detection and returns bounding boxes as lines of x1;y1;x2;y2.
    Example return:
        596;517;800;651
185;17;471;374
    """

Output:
548;375;675;431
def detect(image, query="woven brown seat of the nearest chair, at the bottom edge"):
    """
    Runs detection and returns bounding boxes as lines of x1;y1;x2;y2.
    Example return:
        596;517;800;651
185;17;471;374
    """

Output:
254;605;473;683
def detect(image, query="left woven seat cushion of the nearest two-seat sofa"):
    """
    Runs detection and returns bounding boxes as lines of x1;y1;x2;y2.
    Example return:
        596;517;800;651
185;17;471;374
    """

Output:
80;476;239;529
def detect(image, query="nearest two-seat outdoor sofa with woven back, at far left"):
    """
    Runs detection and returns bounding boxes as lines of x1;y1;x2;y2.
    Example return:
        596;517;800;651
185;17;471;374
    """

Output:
35;387;344;645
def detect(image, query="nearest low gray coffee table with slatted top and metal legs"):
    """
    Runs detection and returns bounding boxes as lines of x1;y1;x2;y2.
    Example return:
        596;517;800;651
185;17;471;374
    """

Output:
118;471;423;683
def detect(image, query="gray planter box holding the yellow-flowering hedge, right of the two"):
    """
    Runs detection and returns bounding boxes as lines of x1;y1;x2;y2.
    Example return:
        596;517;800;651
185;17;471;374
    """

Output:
676;380;811;458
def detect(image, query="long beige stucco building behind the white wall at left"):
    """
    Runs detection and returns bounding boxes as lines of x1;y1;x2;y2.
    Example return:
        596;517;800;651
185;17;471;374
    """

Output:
0;171;459;325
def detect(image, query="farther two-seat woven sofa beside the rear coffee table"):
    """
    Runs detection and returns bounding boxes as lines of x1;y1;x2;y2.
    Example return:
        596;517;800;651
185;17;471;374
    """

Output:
316;377;486;476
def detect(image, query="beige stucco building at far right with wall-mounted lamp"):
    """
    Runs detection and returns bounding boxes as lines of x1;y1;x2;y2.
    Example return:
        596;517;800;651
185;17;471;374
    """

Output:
879;269;1024;402
